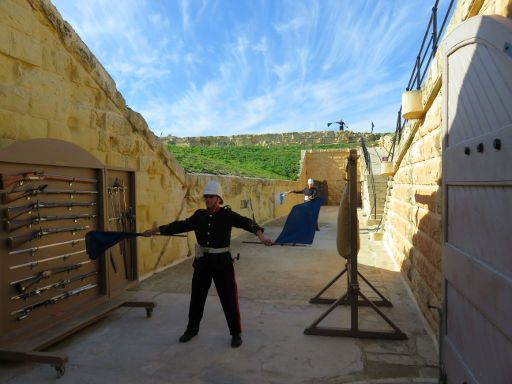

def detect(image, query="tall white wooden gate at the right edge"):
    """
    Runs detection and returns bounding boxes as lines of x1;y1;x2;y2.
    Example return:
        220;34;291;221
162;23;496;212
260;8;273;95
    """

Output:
441;16;512;384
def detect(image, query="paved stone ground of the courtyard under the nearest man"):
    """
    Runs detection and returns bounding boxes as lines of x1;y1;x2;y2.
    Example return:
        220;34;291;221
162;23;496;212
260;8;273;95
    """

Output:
0;207;437;384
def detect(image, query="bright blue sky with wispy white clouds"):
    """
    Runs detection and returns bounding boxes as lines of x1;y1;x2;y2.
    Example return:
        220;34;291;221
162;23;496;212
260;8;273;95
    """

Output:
52;0;448;136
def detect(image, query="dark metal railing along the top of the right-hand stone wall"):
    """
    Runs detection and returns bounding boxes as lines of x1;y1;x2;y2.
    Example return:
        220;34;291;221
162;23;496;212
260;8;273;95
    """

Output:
388;0;455;161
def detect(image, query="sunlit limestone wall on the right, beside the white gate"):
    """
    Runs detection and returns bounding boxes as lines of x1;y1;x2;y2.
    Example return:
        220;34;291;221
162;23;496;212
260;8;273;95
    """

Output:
384;0;512;329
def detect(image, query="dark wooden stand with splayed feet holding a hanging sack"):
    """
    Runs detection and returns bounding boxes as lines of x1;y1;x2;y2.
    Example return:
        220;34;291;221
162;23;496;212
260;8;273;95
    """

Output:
304;149;407;340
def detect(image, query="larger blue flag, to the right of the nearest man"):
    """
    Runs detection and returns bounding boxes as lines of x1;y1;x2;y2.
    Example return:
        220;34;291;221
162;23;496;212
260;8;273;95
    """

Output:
274;196;324;244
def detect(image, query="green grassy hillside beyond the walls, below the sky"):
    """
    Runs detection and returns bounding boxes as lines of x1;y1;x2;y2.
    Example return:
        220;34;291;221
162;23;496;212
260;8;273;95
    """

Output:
167;143;372;180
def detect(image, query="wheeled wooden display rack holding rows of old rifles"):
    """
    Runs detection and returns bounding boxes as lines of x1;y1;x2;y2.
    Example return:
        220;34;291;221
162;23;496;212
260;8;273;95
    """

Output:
0;139;155;377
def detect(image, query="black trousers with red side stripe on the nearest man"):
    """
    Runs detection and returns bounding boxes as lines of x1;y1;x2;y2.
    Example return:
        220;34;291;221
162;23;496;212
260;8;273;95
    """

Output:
187;253;242;335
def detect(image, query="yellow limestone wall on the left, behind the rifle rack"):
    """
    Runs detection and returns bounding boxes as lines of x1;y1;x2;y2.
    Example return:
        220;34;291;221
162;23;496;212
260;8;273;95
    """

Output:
0;0;298;277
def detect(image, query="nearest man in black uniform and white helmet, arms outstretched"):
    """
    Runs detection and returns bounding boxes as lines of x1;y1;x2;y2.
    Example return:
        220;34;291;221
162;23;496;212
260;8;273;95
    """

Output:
144;180;272;348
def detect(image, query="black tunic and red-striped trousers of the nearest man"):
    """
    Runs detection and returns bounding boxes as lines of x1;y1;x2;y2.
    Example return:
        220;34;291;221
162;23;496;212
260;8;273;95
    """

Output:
159;207;263;335
